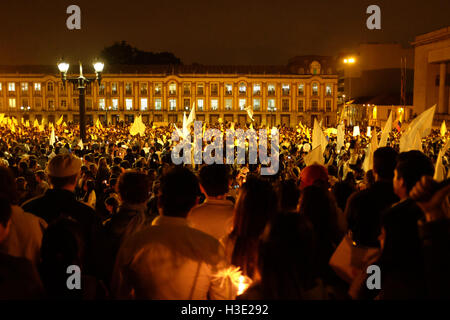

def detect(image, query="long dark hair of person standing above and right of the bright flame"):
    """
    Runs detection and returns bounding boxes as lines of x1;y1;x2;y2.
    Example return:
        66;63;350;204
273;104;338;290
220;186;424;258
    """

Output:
229;176;277;278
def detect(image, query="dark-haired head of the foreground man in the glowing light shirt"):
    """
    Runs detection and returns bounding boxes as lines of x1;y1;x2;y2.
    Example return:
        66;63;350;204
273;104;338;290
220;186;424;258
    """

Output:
158;166;200;218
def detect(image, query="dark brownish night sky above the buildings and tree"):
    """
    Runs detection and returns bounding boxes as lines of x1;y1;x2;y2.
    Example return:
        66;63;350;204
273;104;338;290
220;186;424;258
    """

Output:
0;0;450;65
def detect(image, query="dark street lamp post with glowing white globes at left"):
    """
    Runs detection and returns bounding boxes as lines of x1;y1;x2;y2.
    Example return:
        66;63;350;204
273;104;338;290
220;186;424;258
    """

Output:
58;61;104;141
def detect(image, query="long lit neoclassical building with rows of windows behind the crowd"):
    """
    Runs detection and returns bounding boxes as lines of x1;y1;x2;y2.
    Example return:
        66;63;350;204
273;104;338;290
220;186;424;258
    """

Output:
0;56;337;127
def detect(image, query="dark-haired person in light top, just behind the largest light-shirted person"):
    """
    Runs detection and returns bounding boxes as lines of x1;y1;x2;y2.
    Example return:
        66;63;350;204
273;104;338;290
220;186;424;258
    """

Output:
187;164;234;240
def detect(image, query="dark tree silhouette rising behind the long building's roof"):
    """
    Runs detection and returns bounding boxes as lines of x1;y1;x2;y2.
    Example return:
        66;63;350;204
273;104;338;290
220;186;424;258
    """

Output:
100;41;182;65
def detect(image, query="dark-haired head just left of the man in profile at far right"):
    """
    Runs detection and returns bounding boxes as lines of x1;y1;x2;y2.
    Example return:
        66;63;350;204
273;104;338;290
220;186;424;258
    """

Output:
373;147;398;182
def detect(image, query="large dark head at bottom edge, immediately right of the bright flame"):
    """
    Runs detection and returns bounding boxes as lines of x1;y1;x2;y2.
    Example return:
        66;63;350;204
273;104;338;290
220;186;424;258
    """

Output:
249;212;322;300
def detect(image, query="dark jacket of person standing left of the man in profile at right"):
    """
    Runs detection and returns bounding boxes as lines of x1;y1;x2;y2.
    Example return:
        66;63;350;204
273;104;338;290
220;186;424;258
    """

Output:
345;181;399;247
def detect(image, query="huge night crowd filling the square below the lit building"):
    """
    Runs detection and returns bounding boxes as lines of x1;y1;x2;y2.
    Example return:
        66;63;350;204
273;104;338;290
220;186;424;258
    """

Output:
0;118;450;300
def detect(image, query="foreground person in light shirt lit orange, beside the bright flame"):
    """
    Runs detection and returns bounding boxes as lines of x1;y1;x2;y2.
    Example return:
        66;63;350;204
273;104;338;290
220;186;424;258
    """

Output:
112;167;237;300
